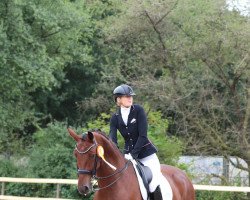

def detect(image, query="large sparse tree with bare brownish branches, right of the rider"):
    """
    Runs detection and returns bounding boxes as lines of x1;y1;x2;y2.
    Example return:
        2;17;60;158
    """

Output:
94;0;250;187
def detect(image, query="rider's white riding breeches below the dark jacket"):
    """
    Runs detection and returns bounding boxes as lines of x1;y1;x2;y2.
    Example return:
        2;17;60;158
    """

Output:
138;153;163;192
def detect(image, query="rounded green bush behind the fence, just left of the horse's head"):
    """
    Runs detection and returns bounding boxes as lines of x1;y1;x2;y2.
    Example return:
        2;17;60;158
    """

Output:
29;123;76;178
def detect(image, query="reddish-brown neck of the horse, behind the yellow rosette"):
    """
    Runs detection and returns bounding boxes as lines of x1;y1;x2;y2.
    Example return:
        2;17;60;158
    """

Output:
94;136;141;200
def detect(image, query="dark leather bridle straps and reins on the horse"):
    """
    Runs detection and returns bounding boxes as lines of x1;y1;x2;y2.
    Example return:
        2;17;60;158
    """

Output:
75;139;131;191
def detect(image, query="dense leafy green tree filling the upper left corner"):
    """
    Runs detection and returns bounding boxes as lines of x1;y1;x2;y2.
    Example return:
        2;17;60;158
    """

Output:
0;0;94;157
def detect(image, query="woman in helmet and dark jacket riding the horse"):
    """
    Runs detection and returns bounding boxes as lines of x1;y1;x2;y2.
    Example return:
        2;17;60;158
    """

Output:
109;84;162;200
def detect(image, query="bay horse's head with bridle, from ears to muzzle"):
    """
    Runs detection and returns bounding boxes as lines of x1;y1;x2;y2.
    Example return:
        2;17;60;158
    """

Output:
68;128;99;195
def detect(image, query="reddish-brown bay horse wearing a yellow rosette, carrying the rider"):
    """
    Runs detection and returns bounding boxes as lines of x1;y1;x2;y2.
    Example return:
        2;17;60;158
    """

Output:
68;128;195;200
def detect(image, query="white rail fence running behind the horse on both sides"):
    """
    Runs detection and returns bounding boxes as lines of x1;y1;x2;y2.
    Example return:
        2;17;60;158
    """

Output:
0;177;250;200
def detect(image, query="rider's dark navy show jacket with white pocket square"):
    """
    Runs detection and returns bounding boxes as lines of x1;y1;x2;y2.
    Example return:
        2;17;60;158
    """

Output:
109;104;157;159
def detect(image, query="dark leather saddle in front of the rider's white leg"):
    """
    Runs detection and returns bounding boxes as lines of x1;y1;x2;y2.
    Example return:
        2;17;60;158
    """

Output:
135;160;153;194
